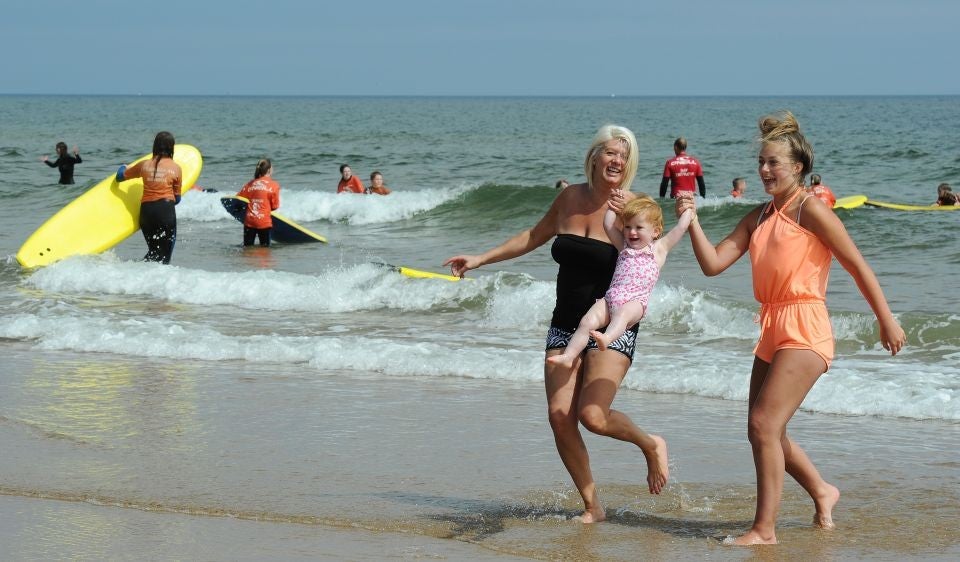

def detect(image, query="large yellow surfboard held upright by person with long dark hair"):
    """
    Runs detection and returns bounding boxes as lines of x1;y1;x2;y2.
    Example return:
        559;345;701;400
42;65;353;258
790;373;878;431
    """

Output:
17;144;203;267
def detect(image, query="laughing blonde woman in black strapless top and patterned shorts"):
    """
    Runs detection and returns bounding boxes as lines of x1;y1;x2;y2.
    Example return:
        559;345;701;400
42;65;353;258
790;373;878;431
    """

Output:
444;125;668;523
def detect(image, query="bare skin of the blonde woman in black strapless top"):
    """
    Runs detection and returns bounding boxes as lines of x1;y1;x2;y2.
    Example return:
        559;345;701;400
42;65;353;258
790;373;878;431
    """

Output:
444;140;669;523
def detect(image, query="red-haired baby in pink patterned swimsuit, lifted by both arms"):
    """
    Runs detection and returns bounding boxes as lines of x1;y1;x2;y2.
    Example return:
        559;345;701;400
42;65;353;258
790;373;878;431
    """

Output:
546;191;693;366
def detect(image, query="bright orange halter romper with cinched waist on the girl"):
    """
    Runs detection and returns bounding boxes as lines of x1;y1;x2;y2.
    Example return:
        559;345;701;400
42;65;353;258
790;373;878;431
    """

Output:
750;191;833;369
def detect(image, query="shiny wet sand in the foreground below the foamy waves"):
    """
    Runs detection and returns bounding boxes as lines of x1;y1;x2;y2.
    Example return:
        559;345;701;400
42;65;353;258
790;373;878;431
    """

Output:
0;353;960;560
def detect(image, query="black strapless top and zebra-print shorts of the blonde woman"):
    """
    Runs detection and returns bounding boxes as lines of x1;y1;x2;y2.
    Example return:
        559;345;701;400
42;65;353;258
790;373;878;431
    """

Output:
547;234;637;360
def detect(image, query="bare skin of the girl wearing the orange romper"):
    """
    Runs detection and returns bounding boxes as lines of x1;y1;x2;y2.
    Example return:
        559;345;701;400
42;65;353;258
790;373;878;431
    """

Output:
676;142;906;545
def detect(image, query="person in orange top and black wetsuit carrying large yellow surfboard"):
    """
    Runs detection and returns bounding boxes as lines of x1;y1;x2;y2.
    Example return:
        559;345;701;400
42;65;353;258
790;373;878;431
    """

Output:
117;131;183;264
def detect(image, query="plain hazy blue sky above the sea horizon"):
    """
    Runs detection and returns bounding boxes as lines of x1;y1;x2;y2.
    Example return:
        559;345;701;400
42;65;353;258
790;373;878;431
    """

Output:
0;0;960;96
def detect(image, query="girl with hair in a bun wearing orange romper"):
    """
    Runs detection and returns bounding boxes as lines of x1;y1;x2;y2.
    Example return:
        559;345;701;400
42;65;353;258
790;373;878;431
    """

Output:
676;111;906;545
